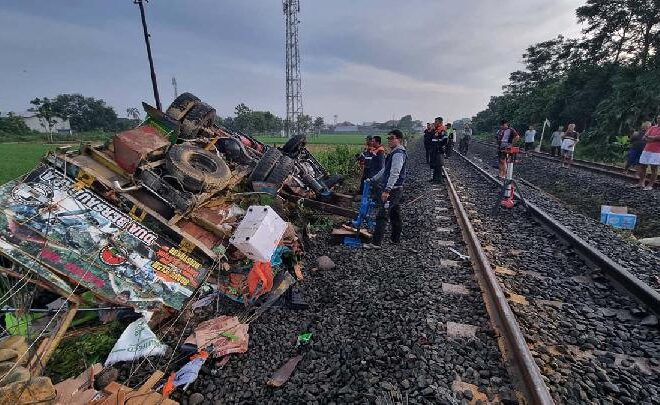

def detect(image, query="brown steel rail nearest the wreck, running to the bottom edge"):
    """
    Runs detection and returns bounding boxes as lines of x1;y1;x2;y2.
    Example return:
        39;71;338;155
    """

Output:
443;169;554;405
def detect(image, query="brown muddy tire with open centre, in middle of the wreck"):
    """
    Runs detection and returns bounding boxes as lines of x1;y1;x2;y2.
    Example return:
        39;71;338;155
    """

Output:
165;145;231;192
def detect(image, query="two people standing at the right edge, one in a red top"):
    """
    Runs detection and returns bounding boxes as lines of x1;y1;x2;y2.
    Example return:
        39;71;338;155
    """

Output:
625;114;660;190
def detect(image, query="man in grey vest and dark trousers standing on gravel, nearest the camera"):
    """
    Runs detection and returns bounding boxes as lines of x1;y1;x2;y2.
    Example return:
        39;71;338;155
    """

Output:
364;129;408;249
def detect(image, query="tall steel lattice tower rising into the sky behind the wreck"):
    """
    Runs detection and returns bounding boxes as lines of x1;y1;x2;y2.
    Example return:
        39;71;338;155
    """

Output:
282;0;303;137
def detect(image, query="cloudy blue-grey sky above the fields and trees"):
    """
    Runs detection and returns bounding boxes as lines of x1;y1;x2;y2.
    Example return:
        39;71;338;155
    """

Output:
0;0;584;123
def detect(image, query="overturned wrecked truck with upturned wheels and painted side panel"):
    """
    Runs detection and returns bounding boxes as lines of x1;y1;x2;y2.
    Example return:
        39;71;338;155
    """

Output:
0;93;354;368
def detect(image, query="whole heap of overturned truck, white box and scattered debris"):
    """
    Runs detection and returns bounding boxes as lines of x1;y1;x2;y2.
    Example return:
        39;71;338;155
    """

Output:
0;93;357;403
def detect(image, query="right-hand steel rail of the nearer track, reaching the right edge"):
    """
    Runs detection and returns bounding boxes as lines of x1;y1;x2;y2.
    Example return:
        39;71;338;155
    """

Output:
456;152;660;315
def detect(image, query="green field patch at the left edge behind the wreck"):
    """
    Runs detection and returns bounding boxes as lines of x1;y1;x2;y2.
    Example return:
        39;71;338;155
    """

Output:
0;143;56;184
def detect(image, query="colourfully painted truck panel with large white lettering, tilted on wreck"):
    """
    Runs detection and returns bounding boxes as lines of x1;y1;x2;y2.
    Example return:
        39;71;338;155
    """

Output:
0;165;210;310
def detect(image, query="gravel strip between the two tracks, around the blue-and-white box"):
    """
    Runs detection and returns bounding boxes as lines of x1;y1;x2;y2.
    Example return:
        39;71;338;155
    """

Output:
468;144;660;291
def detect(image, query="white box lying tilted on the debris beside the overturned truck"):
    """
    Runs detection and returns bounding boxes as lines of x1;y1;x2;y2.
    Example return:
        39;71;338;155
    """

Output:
229;205;288;262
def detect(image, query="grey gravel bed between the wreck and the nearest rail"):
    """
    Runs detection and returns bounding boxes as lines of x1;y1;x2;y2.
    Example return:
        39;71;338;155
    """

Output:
117;143;515;404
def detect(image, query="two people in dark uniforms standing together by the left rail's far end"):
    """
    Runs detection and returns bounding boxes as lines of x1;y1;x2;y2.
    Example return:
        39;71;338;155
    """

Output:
424;117;456;183
